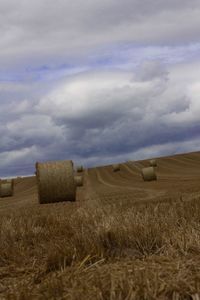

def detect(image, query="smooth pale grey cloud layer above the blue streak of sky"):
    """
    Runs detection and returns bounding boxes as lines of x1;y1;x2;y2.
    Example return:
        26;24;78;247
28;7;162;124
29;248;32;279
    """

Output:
0;0;200;69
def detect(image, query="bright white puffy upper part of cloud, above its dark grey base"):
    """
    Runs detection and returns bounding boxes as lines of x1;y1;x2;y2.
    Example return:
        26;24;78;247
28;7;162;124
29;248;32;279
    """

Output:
35;72;165;123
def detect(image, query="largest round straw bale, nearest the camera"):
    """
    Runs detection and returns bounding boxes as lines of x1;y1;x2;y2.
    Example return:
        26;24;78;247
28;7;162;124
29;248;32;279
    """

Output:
35;160;76;204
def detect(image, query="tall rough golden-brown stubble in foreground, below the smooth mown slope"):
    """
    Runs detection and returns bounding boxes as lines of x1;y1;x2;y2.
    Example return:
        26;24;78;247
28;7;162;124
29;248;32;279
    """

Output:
0;199;200;300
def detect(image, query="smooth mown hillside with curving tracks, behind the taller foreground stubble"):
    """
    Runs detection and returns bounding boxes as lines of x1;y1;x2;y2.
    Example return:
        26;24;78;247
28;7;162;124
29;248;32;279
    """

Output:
0;152;200;209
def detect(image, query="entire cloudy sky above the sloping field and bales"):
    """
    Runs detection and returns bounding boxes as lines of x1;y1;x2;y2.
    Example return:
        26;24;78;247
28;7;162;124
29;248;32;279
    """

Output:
0;0;200;178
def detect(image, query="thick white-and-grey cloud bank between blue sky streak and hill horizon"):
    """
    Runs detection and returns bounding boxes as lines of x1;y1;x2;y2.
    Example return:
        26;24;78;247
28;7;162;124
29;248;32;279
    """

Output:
0;62;200;176
